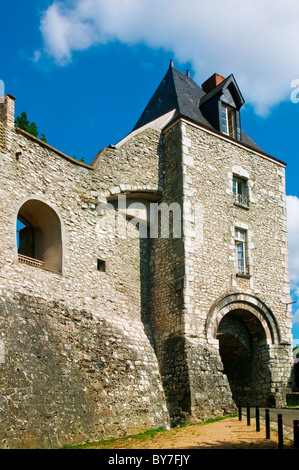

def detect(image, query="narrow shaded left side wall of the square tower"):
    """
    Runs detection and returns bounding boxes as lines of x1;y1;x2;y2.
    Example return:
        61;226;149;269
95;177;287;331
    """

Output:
150;122;190;425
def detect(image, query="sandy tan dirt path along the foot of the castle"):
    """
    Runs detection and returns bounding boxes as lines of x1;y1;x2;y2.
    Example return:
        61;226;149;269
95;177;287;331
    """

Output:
83;418;293;449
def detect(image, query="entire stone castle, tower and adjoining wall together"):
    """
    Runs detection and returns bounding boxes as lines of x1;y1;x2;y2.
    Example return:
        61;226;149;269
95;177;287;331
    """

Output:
0;62;293;448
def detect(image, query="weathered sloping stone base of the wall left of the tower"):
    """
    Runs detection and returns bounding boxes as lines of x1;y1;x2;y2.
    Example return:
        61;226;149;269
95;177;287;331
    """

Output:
0;292;168;448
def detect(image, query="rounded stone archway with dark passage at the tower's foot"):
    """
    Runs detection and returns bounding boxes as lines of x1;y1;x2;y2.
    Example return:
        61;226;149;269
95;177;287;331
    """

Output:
206;293;280;406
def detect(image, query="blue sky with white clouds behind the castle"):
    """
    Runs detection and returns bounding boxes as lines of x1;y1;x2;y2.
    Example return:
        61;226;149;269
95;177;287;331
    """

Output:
0;0;299;344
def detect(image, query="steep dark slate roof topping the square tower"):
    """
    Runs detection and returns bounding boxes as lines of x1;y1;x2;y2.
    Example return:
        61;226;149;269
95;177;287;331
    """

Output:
133;61;262;151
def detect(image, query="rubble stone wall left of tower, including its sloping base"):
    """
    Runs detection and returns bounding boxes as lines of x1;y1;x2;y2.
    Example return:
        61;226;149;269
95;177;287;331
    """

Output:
0;97;168;448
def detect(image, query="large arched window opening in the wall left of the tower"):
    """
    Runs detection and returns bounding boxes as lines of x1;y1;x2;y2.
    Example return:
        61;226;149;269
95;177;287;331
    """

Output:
17;199;62;272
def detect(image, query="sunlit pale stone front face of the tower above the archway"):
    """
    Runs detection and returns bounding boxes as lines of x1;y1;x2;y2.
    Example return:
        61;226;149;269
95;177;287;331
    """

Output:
179;120;291;334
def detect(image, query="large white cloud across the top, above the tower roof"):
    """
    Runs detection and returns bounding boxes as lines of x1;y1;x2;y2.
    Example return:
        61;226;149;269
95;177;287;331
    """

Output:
41;0;299;114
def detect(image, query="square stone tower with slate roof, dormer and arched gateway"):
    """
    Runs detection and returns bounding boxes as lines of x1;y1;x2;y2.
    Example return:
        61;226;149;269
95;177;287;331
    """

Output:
131;63;292;419
